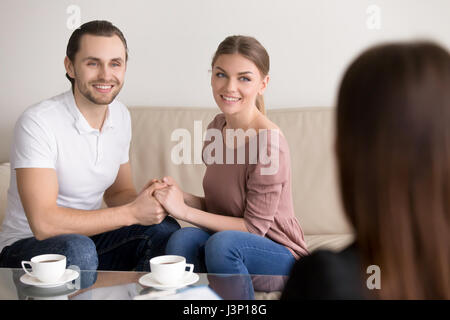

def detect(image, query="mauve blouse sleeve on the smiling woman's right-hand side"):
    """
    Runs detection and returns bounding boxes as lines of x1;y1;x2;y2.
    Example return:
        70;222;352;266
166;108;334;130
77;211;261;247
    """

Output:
244;129;290;236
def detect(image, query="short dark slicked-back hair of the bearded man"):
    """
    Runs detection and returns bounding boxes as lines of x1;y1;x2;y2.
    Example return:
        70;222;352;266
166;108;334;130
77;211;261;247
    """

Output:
66;20;128;86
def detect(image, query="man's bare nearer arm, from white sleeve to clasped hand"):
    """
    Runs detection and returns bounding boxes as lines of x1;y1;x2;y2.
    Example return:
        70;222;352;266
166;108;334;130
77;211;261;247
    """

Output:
16;168;167;240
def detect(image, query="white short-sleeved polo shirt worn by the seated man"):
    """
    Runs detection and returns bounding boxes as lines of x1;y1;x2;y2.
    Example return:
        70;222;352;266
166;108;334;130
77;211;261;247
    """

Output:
0;91;131;252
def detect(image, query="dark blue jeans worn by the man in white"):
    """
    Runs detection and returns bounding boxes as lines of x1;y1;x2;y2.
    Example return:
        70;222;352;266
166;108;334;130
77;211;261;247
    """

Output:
0;217;180;271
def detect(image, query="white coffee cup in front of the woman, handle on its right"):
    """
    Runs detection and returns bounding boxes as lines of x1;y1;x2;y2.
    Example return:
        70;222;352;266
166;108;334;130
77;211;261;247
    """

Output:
150;255;194;285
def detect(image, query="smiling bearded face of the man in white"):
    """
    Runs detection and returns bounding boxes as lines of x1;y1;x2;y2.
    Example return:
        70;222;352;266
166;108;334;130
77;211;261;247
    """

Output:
64;34;126;105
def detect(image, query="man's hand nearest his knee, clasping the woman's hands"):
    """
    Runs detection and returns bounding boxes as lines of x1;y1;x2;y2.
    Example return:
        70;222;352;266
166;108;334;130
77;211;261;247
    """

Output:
130;181;167;226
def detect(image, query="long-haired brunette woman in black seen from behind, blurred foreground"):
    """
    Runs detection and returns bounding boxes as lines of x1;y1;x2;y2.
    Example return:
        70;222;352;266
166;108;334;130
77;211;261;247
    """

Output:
282;42;450;299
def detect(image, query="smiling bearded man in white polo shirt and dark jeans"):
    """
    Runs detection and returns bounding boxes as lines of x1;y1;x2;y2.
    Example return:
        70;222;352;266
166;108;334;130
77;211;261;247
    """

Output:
0;21;179;271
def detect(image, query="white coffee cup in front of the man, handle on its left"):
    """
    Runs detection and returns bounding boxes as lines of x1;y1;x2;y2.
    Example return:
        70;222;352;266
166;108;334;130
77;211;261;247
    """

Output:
22;254;67;283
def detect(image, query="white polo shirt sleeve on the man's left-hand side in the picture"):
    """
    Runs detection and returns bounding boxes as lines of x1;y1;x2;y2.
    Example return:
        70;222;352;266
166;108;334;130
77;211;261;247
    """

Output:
11;113;56;169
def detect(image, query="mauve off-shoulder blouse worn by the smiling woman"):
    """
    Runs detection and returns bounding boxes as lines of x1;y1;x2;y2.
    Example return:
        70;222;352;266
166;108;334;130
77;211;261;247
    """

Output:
202;114;308;259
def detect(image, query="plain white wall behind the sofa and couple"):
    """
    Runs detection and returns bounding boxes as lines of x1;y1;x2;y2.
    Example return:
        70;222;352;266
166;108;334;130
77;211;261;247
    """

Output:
0;0;450;162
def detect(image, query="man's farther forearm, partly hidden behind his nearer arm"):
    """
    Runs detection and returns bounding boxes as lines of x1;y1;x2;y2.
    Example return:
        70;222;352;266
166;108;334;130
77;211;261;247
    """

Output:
103;162;137;207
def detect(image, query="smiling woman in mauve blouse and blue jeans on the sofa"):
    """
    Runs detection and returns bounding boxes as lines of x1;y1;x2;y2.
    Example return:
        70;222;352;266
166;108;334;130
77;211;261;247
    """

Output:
154;36;307;275
